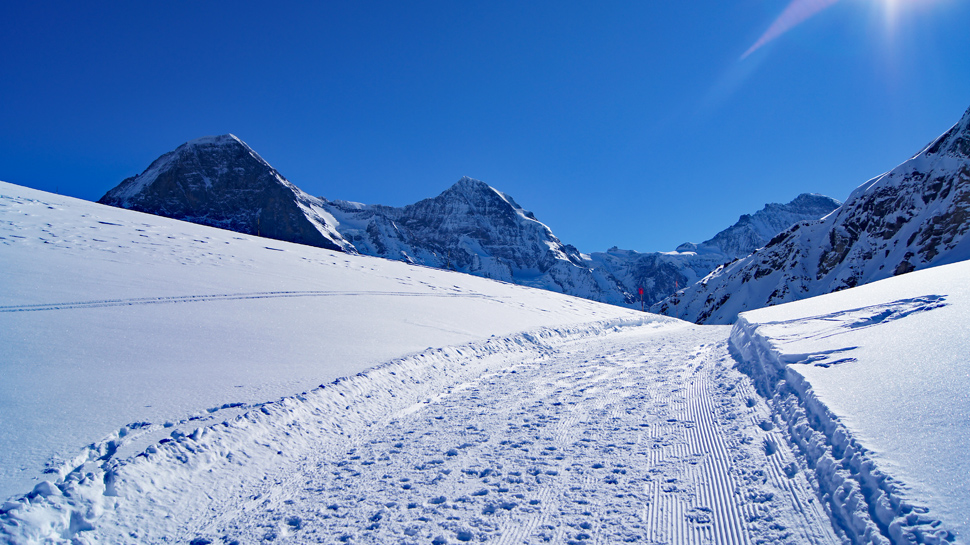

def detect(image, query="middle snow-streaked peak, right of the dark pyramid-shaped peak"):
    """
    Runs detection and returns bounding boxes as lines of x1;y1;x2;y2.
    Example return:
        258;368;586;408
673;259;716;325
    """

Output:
327;178;630;304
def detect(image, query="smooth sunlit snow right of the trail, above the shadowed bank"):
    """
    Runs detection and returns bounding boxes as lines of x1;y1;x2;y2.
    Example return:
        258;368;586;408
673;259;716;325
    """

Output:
733;262;970;536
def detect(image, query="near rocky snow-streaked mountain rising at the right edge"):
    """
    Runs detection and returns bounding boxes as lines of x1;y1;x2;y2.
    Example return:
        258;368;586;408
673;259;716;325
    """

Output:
652;106;970;324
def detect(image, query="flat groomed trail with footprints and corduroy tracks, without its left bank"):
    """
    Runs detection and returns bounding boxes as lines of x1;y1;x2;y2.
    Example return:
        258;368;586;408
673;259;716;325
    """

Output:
195;326;840;544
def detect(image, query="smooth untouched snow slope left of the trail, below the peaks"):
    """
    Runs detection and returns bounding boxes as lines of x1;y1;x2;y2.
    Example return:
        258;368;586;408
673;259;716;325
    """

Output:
0;183;643;500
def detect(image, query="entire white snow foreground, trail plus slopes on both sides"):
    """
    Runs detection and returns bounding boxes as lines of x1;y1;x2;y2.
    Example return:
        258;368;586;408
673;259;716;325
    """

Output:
0;183;970;545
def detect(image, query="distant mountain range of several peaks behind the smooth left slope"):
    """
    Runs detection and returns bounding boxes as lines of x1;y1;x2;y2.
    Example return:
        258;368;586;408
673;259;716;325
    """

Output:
99;134;839;308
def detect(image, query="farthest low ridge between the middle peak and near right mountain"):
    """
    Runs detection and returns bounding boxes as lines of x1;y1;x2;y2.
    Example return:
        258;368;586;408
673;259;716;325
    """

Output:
586;193;841;305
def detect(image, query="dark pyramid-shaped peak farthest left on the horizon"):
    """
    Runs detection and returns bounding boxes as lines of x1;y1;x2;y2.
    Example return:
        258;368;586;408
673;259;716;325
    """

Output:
98;134;353;252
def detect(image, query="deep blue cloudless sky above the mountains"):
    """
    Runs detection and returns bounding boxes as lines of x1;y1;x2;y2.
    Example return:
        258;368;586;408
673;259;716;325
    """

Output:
0;0;970;251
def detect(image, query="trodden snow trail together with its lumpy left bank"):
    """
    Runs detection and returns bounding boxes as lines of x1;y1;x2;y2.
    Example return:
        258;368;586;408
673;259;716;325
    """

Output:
0;321;839;544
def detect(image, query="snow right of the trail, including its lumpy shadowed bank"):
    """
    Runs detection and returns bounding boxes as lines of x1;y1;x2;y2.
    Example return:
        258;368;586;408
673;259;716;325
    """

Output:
731;262;970;543
